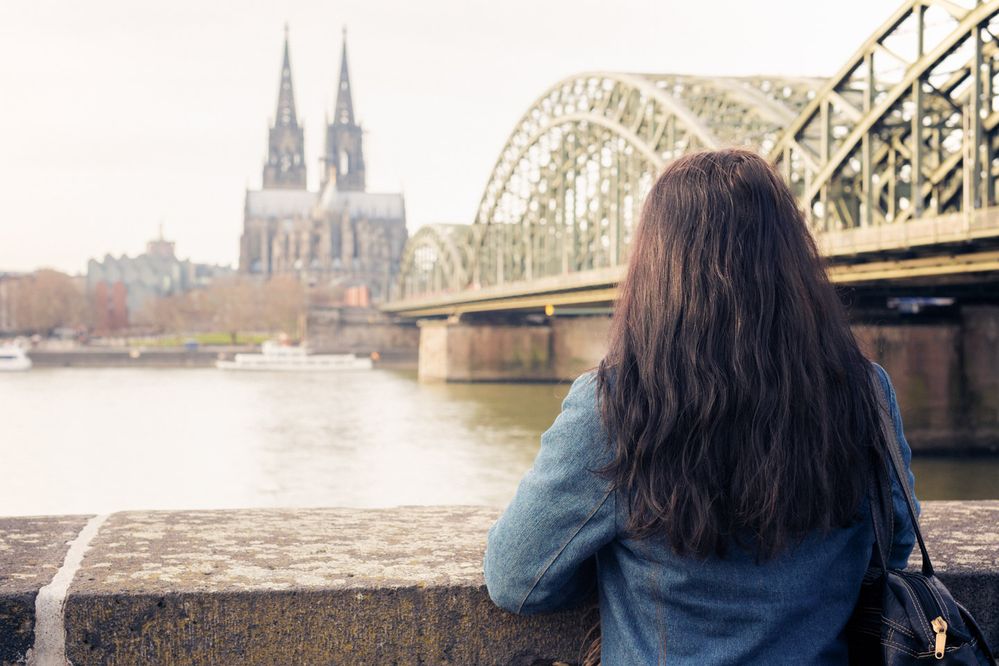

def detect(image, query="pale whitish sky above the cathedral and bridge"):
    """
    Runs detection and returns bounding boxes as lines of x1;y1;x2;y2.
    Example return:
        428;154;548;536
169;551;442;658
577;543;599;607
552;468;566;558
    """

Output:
0;0;899;273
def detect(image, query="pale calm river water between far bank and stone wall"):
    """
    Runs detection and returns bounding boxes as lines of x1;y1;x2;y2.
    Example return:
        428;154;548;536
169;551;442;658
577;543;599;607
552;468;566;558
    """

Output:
0;368;999;516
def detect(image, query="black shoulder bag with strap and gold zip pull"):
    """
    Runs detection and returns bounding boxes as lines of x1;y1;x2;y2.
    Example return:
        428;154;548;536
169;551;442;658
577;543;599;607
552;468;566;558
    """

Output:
847;376;995;666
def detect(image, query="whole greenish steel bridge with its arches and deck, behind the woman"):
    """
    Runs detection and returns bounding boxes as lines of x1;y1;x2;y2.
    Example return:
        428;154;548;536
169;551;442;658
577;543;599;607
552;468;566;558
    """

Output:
386;0;999;315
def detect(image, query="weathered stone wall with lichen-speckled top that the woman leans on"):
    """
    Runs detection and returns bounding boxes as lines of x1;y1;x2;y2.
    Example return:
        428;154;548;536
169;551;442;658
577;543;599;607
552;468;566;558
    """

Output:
0;501;999;666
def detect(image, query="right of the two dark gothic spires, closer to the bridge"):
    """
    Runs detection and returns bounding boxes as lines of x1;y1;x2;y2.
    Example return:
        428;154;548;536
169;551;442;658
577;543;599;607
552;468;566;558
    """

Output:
323;28;365;191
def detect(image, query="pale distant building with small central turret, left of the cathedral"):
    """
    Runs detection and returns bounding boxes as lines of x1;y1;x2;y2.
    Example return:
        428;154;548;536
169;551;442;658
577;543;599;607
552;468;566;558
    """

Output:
87;232;233;332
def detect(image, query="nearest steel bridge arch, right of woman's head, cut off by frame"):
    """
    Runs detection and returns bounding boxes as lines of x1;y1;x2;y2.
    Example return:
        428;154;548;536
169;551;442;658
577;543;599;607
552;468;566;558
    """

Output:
769;0;999;234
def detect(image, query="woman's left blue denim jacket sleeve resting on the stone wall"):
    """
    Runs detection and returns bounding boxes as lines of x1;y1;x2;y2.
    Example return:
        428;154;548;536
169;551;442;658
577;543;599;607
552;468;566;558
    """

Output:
483;372;617;614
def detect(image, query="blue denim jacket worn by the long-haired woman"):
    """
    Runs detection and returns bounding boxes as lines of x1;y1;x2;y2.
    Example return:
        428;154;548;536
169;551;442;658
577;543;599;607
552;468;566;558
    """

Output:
484;367;915;666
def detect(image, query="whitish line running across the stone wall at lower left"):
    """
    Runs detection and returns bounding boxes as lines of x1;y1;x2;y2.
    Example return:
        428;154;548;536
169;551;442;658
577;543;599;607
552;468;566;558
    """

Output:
27;513;110;666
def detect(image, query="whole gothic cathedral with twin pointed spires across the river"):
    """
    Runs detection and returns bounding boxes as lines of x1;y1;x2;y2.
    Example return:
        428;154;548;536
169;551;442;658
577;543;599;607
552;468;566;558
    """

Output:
239;29;407;302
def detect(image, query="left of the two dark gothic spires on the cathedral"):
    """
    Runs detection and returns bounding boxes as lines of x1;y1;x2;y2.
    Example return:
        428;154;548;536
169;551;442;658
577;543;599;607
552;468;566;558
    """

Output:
263;24;306;190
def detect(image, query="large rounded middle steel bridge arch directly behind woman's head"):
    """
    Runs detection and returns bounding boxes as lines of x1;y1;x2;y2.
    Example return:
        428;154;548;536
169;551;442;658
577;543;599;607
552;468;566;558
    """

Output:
468;72;818;287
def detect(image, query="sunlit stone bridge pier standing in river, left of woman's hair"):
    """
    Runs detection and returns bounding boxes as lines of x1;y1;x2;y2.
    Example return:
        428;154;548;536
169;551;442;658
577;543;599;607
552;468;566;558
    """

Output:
418;316;610;382
